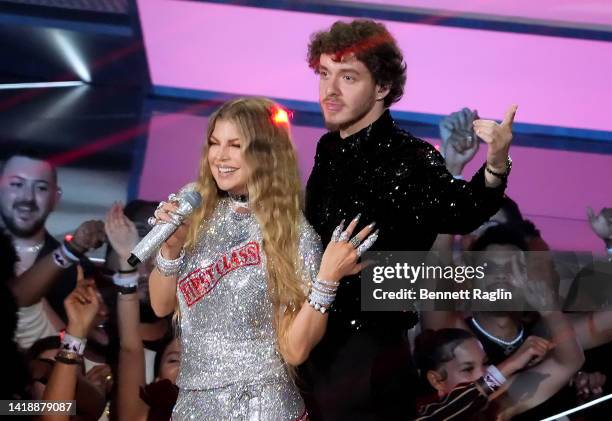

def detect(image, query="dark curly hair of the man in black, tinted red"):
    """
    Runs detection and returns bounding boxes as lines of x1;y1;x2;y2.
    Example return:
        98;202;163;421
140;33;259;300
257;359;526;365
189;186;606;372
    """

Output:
308;19;406;107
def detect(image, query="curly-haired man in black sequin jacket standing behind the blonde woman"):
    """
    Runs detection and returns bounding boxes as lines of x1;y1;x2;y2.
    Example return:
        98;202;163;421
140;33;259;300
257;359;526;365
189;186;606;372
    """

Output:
300;20;516;421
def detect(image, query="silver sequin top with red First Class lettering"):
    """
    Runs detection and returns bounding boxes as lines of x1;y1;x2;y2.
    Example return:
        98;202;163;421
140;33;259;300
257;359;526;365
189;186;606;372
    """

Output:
177;199;322;390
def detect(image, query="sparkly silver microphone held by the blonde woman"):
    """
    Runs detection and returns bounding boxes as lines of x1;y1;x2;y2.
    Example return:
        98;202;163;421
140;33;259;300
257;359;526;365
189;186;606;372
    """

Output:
128;189;202;267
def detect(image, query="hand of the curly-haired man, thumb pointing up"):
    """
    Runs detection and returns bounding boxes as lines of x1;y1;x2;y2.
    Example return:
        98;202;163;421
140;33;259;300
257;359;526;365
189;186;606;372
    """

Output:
473;105;518;173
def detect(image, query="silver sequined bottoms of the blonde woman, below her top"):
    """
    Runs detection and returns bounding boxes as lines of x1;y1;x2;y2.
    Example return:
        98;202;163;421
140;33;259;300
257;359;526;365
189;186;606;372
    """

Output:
172;382;306;421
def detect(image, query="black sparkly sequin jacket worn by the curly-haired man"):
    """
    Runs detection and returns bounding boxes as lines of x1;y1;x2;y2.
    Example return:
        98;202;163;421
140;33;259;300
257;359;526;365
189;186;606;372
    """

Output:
306;110;506;327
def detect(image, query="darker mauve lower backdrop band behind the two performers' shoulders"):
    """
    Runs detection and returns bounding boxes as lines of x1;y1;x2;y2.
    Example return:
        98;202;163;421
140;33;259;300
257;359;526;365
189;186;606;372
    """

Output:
139;110;612;252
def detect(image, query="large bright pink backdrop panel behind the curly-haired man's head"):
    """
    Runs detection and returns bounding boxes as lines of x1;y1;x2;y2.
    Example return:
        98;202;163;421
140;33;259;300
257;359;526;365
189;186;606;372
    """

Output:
138;0;612;131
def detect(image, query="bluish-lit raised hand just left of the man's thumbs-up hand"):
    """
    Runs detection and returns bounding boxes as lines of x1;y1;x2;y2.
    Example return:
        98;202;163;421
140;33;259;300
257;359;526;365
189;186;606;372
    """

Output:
439;108;479;176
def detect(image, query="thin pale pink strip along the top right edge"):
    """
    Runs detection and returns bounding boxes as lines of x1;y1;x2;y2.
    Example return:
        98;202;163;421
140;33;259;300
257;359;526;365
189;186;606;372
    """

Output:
348;0;612;29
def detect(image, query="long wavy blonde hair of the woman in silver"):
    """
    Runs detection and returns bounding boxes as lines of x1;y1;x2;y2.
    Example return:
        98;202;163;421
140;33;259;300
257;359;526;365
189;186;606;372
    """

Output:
186;98;306;360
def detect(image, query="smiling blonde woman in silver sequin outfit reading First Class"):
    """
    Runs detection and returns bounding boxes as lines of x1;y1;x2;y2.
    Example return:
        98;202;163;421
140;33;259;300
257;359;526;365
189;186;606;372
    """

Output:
149;98;375;421
